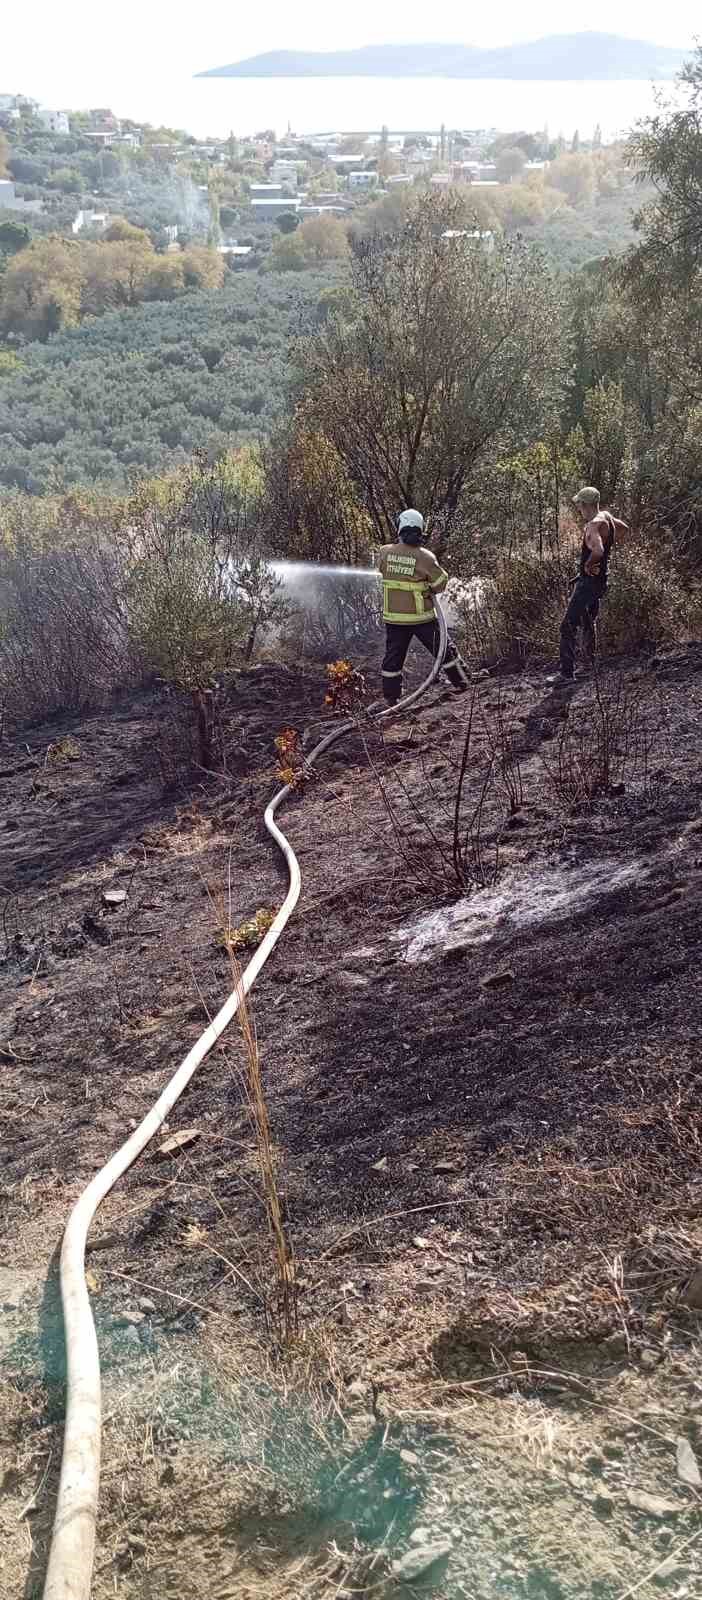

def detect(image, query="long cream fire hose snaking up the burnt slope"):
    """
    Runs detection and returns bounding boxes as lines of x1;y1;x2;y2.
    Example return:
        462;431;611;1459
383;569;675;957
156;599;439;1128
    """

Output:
43;603;448;1600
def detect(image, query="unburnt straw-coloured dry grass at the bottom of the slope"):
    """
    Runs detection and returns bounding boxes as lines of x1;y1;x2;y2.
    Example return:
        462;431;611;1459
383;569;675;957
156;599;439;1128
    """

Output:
0;1203;699;1600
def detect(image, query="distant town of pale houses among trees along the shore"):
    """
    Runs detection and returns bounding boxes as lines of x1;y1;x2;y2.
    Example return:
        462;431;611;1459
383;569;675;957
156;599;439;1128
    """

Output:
0;93;614;264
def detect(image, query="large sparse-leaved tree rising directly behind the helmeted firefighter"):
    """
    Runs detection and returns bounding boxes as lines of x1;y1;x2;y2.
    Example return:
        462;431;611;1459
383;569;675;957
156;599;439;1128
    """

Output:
299;195;566;536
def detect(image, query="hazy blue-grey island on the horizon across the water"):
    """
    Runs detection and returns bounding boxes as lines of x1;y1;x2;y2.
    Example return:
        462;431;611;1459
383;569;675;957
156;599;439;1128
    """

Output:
195;34;689;82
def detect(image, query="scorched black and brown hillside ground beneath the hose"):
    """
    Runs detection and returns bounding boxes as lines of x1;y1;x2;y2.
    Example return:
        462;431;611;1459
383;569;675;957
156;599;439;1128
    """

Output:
0;646;702;1600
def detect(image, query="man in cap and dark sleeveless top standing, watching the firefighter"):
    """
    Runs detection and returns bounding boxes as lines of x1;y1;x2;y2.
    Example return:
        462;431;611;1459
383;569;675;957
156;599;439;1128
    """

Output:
560;486;628;683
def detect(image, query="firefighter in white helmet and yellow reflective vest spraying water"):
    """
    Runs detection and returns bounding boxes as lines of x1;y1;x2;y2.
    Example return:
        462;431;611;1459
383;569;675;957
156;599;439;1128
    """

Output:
377;510;469;706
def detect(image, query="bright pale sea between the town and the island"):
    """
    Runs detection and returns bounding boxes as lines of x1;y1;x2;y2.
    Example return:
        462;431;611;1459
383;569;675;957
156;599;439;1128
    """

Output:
85;77;673;141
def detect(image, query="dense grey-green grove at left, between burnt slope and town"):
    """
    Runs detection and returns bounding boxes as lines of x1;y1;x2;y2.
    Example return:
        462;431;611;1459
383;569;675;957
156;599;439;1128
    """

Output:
0;267;337;494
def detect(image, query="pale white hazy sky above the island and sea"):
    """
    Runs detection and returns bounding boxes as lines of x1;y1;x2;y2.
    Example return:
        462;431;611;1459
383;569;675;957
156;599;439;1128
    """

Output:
0;0;702;106
